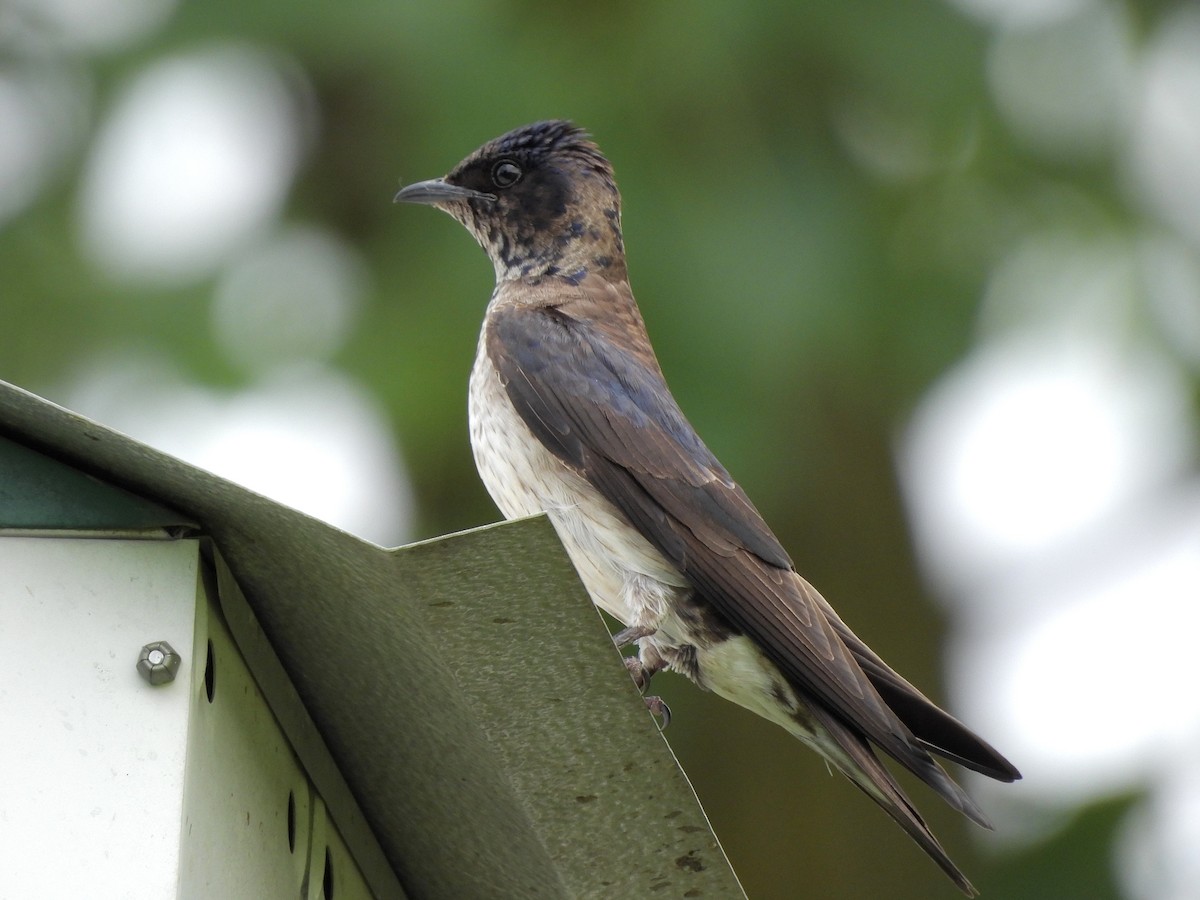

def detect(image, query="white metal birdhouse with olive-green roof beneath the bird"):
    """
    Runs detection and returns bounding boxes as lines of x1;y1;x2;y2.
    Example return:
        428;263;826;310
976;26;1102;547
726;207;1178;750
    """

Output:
0;383;743;900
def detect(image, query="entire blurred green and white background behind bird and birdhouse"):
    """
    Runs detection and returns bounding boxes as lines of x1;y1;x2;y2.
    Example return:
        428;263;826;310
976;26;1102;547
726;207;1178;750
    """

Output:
0;0;1200;900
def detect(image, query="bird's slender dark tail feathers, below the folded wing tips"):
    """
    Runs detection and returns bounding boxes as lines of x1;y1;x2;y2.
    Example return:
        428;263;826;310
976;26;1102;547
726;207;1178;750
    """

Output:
809;703;978;896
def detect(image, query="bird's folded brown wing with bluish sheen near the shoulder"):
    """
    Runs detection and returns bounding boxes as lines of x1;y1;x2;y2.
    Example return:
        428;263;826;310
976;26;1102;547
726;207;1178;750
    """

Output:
486;306;958;777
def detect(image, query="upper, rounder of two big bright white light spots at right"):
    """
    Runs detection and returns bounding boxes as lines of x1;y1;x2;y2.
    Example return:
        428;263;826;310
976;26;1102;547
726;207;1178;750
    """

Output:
901;337;1193;604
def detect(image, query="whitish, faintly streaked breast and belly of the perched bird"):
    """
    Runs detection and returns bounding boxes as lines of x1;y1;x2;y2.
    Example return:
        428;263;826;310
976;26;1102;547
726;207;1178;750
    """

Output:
468;341;686;629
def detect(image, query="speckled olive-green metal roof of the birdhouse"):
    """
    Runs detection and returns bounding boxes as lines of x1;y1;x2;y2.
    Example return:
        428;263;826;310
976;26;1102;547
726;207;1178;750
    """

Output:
0;382;744;900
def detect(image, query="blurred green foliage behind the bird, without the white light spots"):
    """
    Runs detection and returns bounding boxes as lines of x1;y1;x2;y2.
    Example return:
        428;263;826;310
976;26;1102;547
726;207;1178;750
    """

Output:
0;0;1156;900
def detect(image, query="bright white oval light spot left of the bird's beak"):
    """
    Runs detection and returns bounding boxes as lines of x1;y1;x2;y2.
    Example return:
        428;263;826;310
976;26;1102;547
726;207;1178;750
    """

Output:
80;46;304;283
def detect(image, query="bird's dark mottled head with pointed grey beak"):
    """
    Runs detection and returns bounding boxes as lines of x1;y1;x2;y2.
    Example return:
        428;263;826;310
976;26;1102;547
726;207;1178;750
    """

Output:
396;121;625;283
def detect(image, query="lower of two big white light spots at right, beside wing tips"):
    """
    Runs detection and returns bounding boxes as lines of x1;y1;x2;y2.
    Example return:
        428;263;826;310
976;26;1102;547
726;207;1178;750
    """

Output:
953;504;1200;808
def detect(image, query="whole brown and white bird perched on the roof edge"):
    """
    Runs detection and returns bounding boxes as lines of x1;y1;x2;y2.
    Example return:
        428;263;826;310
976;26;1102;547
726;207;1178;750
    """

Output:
396;121;1020;896
